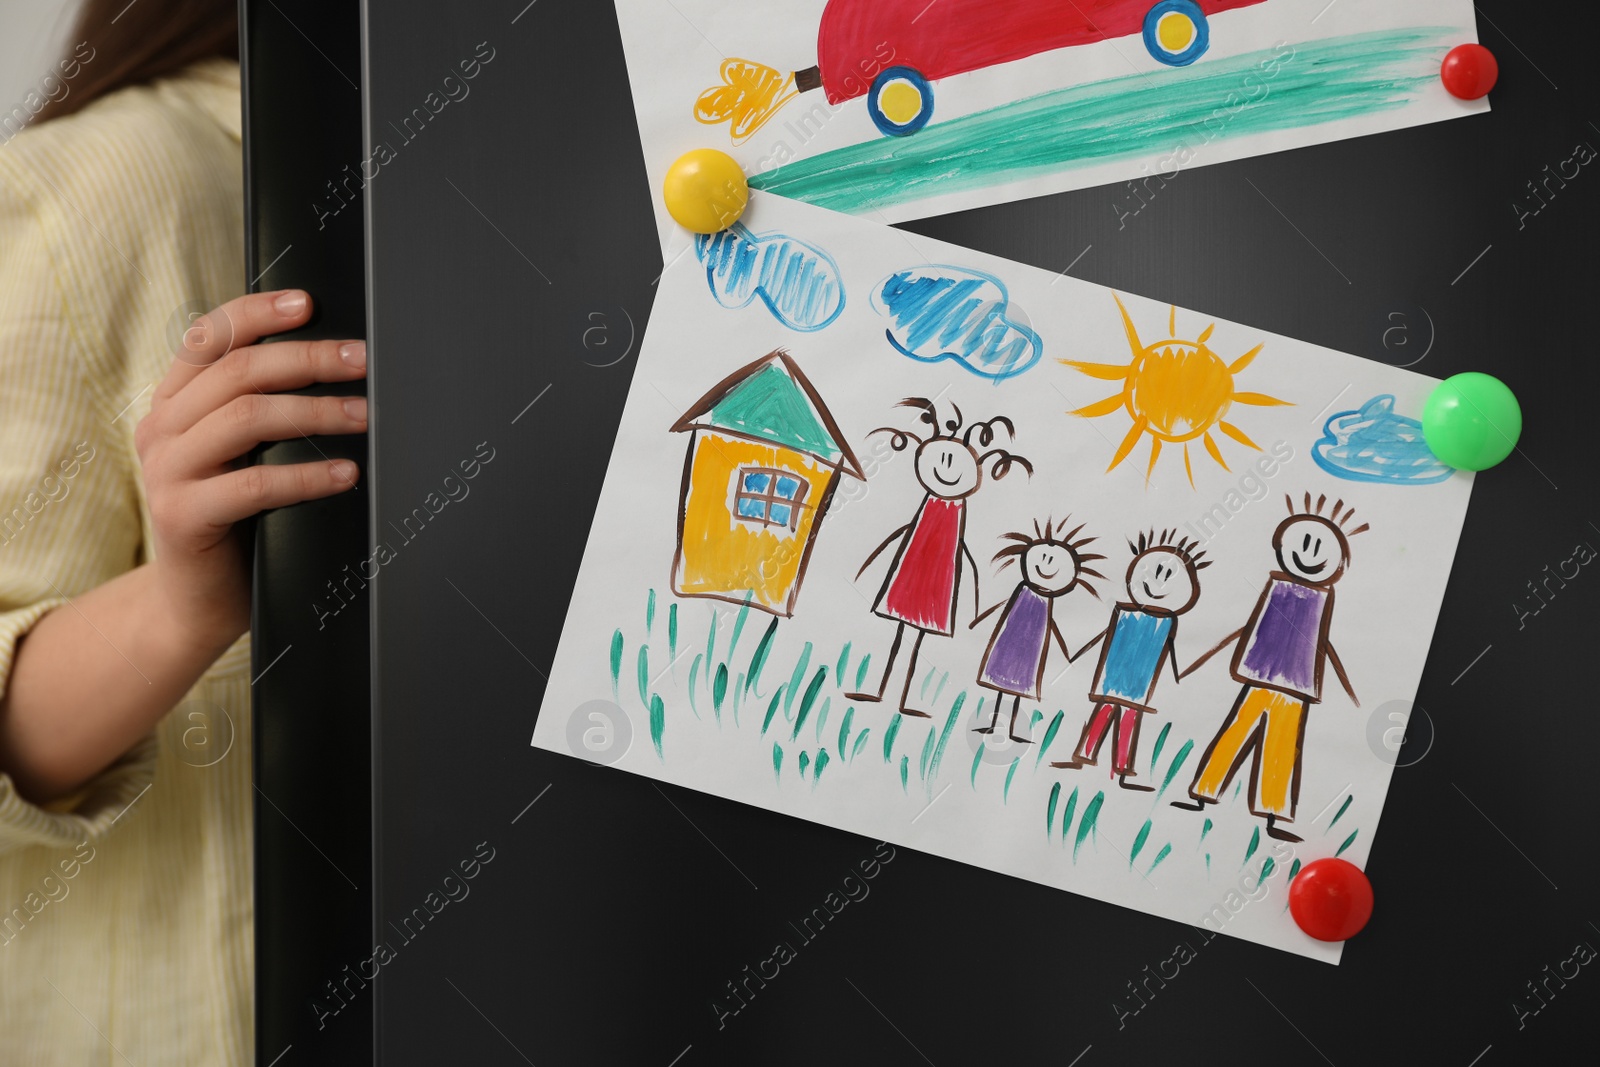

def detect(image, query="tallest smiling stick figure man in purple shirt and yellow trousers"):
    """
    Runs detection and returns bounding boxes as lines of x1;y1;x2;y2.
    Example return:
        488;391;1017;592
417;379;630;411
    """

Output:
1173;493;1366;841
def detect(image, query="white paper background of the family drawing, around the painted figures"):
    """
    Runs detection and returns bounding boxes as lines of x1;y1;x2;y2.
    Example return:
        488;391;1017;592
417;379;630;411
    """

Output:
533;194;1472;961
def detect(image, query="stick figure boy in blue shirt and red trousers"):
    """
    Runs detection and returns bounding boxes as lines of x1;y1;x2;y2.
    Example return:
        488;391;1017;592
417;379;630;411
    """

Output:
1051;530;1211;792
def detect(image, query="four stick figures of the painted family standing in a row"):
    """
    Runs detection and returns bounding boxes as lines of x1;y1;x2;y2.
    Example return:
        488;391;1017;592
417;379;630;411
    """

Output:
848;397;1368;840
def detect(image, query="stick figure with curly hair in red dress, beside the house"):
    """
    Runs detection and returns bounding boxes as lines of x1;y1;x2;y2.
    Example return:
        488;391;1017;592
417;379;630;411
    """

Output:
846;397;1034;718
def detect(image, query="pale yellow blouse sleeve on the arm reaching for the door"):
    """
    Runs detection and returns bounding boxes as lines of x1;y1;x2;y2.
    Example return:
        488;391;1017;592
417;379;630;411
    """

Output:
0;156;157;853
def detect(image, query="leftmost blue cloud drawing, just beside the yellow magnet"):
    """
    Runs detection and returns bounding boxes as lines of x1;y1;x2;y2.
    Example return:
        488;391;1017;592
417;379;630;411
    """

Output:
694;222;845;333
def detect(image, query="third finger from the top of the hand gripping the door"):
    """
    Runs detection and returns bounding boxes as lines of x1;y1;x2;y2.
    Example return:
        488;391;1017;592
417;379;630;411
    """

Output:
173;394;366;477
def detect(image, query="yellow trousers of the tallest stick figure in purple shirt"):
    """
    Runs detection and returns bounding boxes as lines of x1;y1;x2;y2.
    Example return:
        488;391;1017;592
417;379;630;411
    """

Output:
1189;685;1306;819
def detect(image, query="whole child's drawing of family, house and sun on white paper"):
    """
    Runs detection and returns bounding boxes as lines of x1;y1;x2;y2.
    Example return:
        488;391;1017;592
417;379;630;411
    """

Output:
531;187;1472;966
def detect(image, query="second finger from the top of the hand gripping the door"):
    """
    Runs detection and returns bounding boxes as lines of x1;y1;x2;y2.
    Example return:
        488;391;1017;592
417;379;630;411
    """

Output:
157;341;366;434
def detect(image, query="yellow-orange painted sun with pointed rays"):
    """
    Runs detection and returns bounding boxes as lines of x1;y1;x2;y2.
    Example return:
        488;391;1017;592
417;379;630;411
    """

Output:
1061;293;1291;488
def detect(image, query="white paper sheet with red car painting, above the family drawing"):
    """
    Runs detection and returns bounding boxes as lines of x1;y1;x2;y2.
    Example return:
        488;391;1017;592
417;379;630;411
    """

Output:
616;0;1488;247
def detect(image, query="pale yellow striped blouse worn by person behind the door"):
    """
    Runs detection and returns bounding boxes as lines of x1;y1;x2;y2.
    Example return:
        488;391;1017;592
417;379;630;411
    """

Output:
0;59;254;1067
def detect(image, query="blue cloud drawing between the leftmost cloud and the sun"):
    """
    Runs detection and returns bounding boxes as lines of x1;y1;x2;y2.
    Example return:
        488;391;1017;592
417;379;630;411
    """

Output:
872;264;1045;382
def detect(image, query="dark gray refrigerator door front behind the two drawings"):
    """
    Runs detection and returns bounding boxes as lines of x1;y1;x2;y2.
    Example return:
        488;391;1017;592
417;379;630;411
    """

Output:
360;0;1600;1067
